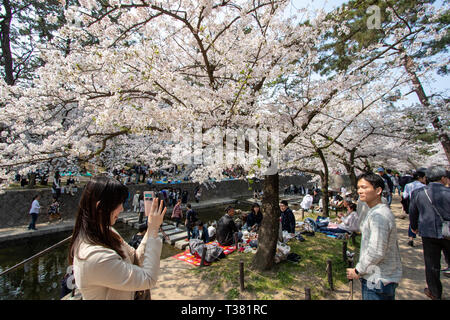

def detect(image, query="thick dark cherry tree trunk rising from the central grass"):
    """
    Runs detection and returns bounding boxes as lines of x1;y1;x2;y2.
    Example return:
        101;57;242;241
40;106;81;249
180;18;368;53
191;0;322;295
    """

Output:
252;173;280;271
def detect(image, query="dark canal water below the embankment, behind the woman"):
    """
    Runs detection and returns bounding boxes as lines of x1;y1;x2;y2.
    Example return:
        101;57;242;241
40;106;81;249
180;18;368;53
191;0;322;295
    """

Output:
0;204;250;300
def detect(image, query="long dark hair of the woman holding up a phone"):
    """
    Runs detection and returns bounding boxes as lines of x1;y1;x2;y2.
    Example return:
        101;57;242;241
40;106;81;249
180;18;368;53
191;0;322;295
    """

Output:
69;176;128;265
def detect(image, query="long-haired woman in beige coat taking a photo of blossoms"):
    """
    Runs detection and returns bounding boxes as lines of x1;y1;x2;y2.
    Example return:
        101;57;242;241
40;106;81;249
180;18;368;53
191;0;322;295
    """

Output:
69;177;166;300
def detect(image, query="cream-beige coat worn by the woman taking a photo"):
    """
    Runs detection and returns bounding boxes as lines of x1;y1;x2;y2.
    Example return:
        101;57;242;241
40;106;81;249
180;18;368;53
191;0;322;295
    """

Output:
73;230;162;300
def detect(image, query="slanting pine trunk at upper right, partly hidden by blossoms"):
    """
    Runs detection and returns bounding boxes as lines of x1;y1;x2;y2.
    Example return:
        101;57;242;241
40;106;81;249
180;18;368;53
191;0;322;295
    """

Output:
403;55;450;163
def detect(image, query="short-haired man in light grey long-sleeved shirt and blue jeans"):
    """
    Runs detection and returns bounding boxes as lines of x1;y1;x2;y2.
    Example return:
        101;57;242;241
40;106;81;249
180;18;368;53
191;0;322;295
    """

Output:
347;173;402;300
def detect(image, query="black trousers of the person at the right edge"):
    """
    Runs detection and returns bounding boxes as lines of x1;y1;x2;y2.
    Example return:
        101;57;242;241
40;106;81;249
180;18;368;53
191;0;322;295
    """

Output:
422;237;450;299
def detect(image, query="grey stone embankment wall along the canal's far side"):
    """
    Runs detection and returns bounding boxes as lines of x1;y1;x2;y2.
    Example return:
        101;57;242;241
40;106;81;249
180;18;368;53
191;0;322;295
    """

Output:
0;176;311;228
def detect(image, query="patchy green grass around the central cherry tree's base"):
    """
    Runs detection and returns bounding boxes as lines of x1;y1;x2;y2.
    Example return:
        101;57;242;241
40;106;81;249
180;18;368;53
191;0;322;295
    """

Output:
190;214;360;300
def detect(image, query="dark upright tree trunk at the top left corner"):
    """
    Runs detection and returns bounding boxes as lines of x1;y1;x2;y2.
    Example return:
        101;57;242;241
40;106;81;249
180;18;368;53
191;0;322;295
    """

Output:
0;0;15;86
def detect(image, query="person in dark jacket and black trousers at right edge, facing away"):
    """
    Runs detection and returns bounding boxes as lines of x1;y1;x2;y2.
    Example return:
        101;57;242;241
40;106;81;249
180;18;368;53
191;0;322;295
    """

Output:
409;166;450;300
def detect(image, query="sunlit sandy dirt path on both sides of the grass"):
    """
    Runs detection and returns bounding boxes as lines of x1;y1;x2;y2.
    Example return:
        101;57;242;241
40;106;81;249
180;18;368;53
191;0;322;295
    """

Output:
152;195;450;300
